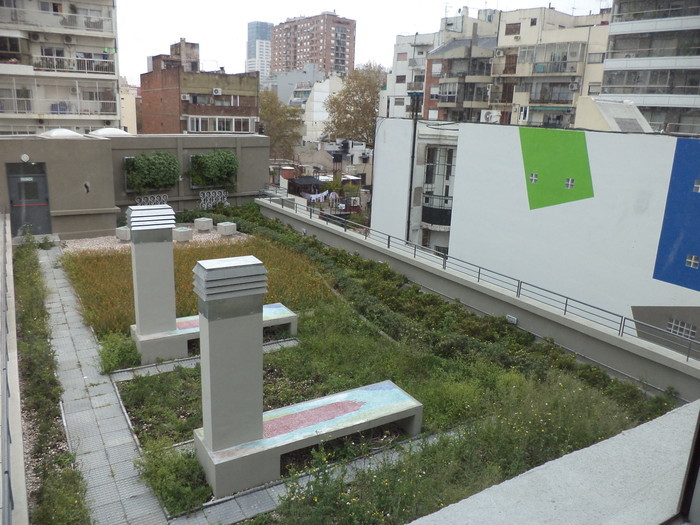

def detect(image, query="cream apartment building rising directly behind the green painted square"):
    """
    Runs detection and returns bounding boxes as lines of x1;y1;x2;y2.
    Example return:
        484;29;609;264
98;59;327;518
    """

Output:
490;7;610;128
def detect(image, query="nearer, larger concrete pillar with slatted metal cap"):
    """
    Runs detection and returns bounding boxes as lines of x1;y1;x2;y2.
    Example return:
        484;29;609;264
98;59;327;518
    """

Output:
193;255;267;452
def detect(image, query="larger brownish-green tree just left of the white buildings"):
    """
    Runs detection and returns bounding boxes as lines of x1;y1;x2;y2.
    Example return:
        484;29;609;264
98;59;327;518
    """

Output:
324;62;386;147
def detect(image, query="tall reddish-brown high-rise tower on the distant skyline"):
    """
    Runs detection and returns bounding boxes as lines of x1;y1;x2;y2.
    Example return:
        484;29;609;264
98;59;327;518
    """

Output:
270;12;355;76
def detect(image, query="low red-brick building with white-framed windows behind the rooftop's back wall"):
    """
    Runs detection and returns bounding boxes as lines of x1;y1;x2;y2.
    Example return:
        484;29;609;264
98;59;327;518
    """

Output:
141;39;259;134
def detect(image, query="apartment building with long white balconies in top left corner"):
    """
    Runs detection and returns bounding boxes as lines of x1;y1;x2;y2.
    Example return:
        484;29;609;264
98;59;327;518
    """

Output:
0;0;120;135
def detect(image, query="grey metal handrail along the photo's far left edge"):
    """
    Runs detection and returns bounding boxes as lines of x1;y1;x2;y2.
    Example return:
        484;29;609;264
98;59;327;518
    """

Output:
0;210;14;525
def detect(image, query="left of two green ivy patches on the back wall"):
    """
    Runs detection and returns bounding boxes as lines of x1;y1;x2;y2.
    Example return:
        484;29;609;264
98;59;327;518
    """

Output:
125;151;180;193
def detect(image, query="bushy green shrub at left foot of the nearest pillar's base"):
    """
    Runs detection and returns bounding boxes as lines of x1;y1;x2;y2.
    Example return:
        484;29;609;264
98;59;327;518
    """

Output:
136;440;211;516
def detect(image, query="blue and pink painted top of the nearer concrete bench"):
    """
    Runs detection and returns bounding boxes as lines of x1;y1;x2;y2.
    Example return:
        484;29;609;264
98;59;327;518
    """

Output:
195;381;423;461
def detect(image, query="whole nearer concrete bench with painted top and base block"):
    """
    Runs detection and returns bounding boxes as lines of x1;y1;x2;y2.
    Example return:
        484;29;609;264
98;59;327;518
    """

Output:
194;381;423;498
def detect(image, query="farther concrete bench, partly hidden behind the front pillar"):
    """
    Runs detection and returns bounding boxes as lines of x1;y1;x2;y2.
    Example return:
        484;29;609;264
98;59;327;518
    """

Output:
131;303;299;365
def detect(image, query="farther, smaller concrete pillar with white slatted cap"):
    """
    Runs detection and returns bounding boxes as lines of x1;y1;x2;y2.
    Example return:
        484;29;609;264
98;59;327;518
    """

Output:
126;204;176;335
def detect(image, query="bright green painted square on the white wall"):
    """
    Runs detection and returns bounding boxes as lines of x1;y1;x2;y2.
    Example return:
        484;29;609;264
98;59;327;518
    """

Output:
520;128;593;210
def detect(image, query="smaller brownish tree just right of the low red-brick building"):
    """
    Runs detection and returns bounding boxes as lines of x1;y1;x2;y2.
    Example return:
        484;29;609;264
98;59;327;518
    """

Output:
260;91;304;159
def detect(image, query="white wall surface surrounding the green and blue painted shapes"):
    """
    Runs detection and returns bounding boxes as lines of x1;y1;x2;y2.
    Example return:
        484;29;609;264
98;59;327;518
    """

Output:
448;124;698;317
